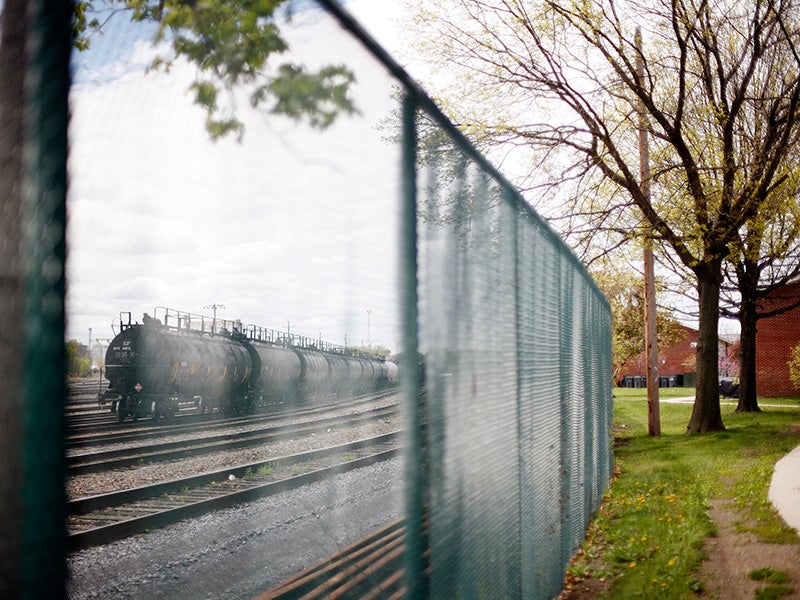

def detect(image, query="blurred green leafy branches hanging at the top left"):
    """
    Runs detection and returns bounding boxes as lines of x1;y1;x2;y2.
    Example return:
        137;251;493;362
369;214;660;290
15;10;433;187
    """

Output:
73;0;357;139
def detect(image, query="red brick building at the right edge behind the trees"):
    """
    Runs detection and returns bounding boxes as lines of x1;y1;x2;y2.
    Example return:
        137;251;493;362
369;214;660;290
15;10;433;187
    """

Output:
756;282;800;398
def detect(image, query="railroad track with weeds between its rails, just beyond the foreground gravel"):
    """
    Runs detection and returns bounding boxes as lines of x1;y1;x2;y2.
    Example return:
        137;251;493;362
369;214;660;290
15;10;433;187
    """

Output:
67;432;399;550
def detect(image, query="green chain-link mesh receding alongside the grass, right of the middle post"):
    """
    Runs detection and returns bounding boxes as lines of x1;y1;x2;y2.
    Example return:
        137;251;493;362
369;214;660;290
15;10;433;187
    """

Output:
406;90;612;598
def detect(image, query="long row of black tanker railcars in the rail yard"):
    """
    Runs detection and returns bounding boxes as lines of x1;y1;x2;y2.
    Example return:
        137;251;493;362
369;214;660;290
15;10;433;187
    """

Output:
98;308;398;422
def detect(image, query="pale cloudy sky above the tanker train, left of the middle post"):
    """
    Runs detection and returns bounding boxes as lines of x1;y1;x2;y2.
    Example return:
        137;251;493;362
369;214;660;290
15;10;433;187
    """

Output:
67;0;406;350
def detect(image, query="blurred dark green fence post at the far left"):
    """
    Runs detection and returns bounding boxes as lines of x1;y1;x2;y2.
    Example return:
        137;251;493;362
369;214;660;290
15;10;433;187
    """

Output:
20;0;72;598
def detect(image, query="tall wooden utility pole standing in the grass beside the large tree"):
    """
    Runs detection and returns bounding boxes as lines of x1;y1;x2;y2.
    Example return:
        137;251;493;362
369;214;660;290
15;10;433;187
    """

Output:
636;27;661;435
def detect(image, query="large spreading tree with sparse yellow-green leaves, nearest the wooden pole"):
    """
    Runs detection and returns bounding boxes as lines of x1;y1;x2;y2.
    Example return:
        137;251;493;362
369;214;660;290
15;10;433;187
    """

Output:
406;0;800;433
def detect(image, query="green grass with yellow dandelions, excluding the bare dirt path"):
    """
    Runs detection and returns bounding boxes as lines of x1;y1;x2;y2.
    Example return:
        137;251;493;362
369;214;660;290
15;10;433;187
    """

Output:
569;388;800;599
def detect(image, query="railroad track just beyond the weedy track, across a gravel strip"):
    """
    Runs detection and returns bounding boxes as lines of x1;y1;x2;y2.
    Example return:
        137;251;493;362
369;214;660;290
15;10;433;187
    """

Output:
65;404;399;476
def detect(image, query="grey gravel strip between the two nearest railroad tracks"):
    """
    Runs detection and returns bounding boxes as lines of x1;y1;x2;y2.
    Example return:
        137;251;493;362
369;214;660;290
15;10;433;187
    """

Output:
68;459;402;600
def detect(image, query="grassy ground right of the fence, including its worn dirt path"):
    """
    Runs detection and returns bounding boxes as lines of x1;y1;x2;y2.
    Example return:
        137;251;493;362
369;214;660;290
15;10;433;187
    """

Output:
561;388;800;600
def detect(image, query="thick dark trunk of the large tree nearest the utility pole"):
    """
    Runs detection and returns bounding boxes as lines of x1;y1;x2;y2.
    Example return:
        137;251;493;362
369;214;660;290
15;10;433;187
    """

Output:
686;260;725;433
